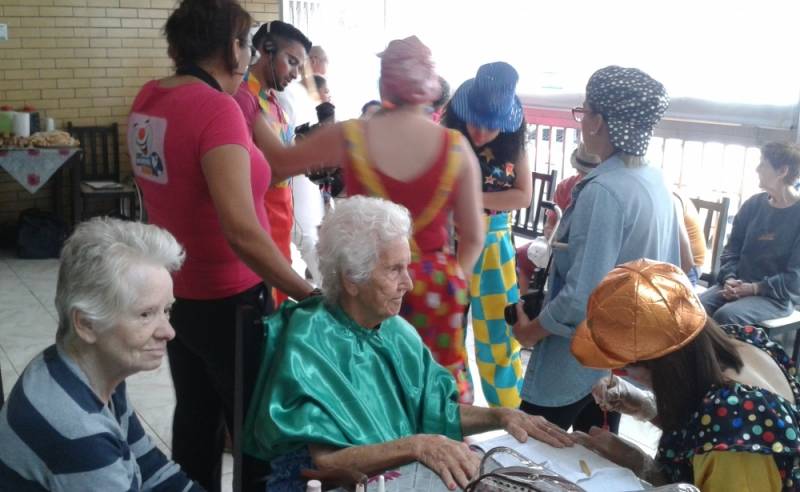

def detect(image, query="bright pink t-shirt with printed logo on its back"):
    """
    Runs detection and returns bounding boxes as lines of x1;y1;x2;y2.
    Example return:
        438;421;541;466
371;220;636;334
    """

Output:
128;81;271;299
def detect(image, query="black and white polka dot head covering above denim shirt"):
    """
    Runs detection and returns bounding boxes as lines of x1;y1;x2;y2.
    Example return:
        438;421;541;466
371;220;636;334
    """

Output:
586;65;669;156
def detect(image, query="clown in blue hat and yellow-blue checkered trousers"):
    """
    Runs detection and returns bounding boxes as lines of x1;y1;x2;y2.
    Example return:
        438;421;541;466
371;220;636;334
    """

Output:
442;62;532;408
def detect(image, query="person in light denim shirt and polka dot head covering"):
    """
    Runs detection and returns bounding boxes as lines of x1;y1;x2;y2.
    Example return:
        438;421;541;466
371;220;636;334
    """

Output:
514;66;680;431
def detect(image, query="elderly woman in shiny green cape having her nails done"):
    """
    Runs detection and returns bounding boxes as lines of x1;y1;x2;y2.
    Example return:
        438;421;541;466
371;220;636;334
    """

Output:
244;196;572;490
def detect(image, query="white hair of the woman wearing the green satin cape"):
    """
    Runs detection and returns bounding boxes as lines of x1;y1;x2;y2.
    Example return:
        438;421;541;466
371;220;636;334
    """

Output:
317;196;411;303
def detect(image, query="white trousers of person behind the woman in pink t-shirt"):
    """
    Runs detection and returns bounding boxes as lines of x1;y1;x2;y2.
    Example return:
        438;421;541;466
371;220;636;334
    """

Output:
292;176;325;285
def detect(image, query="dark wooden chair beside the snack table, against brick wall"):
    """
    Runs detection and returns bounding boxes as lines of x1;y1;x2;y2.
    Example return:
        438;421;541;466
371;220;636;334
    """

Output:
67;122;142;223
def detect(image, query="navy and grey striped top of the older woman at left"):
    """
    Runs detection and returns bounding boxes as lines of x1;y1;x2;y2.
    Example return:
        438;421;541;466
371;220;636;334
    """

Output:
0;347;202;492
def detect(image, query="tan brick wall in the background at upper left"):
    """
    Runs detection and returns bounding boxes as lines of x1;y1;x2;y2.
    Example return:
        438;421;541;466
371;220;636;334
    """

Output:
0;0;280;224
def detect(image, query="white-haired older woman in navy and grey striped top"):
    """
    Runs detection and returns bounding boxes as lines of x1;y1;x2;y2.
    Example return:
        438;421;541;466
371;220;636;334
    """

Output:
0;218;202;491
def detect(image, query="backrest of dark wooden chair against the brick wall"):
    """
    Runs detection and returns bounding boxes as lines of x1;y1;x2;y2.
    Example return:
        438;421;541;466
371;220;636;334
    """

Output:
67;122;120;182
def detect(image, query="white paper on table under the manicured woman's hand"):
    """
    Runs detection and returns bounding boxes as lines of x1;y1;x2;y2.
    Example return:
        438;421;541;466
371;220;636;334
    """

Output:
478;434;643;492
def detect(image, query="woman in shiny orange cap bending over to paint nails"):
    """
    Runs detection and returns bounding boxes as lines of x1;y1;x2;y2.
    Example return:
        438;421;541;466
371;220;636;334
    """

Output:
571;259;800;491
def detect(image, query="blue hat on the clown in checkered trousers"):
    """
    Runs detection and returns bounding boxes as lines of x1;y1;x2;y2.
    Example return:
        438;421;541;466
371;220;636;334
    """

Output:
450;62;522;132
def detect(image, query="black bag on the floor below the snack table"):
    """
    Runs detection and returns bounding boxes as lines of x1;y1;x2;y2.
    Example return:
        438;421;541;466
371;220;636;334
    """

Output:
17;208;67;259
